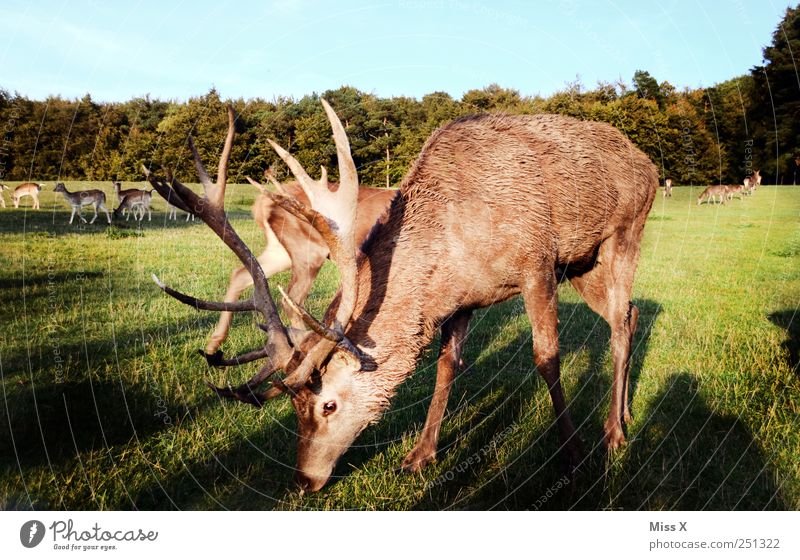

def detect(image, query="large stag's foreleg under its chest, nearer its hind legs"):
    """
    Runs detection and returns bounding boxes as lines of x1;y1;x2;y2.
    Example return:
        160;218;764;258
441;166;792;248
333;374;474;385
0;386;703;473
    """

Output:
522;267;584;470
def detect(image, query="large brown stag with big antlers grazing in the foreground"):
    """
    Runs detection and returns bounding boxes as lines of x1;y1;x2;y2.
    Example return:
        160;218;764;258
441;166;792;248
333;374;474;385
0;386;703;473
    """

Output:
145;100;659;491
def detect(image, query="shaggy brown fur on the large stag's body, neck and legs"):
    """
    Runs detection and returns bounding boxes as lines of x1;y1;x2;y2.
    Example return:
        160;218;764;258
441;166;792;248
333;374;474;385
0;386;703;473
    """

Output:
294;111;658;490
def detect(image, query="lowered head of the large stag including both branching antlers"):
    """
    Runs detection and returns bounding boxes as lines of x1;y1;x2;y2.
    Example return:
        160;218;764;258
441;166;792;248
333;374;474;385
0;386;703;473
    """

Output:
144;100;385;491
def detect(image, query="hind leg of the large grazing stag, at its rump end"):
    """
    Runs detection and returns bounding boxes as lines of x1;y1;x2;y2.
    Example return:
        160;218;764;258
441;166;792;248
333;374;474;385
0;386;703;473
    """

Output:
570;230;641;450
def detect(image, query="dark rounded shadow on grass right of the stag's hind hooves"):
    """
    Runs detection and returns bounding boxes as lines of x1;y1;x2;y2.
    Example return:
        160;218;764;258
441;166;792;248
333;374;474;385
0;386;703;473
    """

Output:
605;372;786;511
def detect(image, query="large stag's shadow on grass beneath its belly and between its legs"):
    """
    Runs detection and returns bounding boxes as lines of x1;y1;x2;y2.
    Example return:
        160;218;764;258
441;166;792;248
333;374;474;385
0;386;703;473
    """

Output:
406;300;660;509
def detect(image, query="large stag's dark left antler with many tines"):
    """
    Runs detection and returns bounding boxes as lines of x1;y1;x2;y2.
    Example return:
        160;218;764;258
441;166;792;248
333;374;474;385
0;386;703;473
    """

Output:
142;107;295;390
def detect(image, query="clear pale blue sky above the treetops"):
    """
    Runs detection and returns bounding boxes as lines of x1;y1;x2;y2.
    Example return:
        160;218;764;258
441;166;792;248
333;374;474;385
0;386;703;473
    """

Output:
0;0;789;101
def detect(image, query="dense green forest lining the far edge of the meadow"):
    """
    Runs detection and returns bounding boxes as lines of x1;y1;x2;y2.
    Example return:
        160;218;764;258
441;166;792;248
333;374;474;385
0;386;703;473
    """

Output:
0;6;800;186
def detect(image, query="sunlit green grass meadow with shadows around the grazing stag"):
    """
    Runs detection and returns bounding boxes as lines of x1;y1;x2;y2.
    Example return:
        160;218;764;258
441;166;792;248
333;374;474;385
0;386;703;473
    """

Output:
0;183;800;510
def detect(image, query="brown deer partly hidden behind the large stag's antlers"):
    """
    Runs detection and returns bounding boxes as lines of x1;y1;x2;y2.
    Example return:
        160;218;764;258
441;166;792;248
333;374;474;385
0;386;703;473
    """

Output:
203;172;397;354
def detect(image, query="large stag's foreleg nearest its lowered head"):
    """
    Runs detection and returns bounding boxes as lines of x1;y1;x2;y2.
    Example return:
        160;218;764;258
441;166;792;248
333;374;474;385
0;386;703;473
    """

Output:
402;310;472;472
